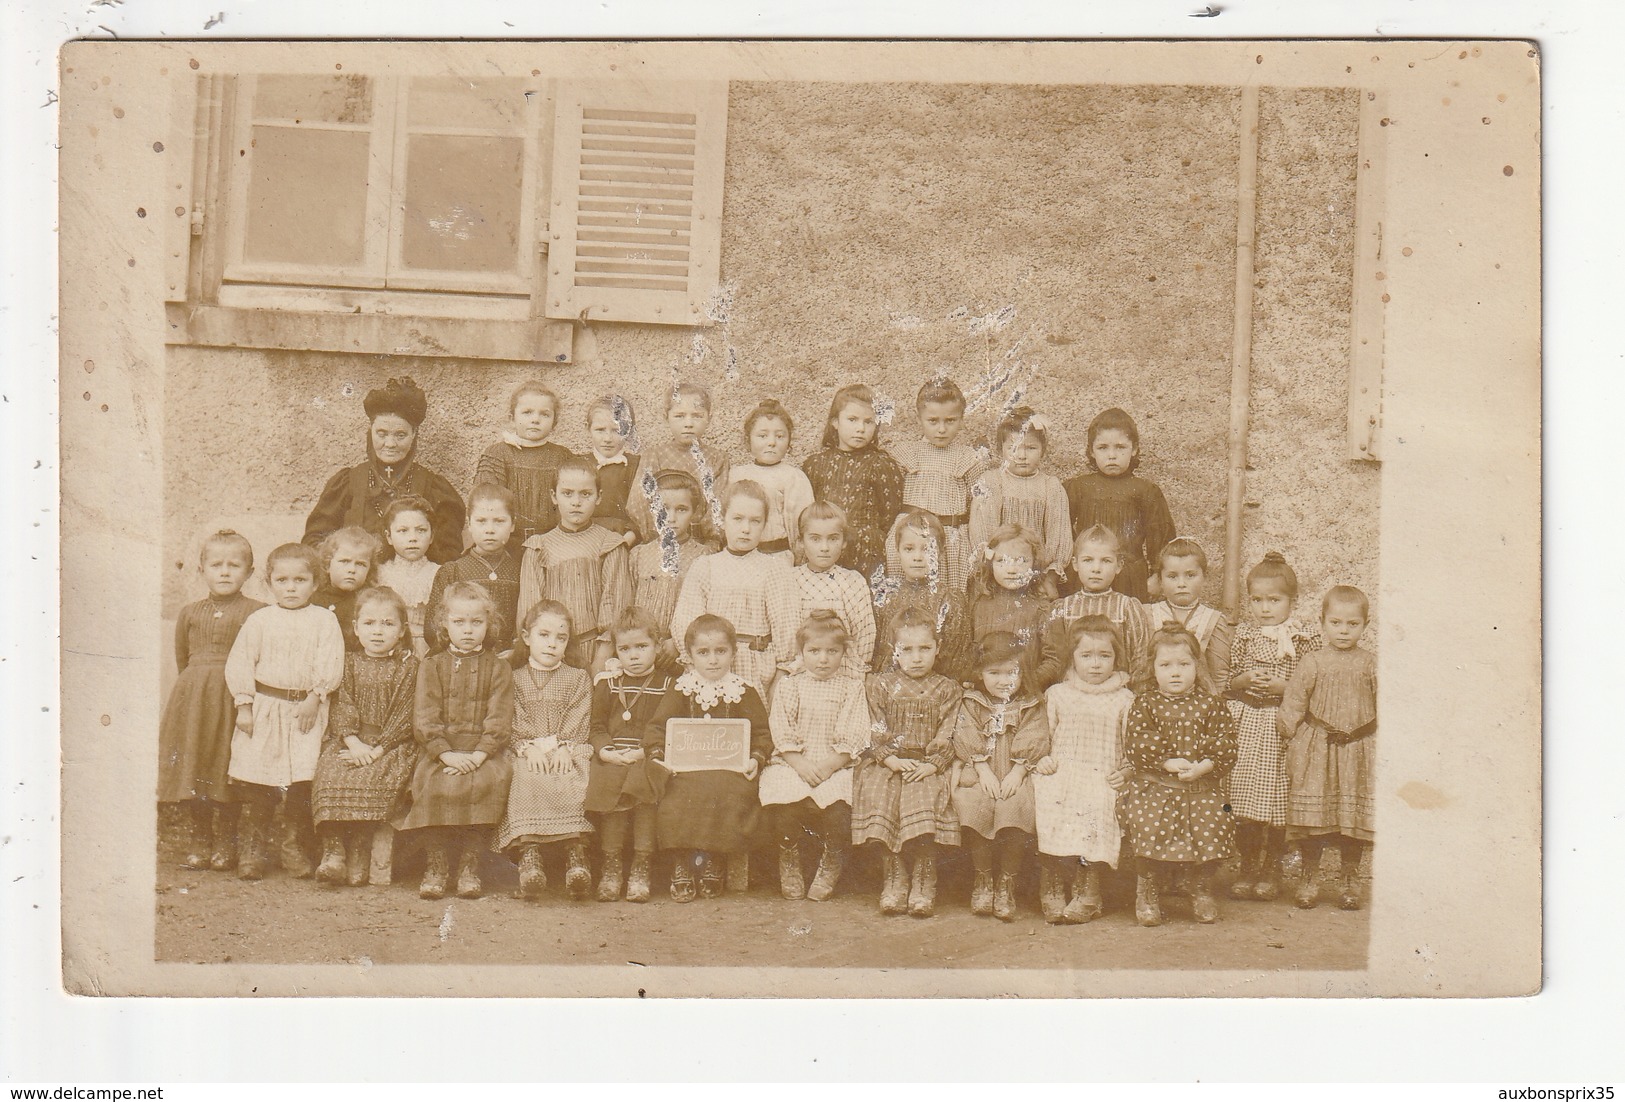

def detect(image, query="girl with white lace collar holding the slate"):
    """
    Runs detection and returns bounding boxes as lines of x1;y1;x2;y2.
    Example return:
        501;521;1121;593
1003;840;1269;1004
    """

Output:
644;613;774;904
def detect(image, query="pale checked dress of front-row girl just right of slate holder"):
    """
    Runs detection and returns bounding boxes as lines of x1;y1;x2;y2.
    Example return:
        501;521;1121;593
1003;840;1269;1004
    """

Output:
761;671;869;808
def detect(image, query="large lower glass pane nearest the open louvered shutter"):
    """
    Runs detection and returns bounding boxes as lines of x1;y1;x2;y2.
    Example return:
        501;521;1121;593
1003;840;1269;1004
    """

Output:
401;133;525;271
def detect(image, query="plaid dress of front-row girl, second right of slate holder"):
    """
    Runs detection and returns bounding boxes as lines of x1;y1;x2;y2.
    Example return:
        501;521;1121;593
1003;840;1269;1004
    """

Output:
852;671;960;853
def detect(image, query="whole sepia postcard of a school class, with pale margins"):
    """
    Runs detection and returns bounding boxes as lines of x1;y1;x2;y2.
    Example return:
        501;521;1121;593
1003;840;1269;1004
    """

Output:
60;41;1542;998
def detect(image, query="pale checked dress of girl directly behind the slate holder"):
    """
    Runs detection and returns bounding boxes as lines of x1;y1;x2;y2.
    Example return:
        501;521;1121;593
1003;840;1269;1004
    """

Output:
671;551;801;697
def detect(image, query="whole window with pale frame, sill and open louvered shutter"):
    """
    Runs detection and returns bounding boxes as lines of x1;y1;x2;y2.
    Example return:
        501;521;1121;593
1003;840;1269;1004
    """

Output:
169;73;728;361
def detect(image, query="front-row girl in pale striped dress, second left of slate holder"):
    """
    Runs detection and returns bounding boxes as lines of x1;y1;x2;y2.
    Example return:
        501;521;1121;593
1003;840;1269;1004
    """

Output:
496;601;593;899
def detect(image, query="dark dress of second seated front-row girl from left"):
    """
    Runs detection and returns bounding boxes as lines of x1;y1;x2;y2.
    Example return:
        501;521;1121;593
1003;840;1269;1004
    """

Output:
395;650;514;831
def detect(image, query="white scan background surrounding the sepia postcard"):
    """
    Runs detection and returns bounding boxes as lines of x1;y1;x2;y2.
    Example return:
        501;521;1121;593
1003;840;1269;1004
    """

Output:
0;0;1625;1082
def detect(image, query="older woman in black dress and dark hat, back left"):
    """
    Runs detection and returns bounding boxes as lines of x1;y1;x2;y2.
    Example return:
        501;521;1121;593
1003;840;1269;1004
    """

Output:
304;375;465;562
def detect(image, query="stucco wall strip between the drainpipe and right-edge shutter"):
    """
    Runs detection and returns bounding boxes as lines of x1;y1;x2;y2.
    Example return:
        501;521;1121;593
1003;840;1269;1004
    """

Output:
1245;89;1381;630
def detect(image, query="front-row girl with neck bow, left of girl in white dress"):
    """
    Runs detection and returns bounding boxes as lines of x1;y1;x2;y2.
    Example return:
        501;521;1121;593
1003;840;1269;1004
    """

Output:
954;631;1050;922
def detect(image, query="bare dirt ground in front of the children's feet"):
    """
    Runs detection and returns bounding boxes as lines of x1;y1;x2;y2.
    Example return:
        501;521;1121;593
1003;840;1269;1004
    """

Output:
154;812;1370;970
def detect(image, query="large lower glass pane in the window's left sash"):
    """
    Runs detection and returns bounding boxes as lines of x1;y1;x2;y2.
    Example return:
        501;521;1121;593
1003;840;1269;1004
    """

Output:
242;127;371;268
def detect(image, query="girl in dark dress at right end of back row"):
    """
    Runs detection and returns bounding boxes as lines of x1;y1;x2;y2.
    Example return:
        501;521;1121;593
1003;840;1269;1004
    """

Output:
1066;410;1173;601
